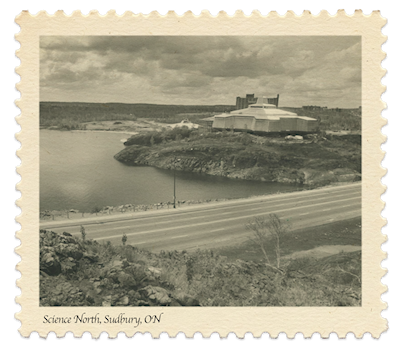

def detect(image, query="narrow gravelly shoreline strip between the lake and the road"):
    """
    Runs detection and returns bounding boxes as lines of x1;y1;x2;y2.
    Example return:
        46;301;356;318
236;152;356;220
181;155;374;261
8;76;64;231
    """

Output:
39;181;362;224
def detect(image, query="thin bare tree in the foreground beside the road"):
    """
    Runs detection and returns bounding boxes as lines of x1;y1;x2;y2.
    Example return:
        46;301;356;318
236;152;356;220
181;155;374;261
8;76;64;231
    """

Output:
246;213;290;272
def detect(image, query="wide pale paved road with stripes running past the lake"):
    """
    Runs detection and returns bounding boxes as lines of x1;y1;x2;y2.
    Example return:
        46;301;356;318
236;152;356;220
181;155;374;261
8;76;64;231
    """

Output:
40;183;361;252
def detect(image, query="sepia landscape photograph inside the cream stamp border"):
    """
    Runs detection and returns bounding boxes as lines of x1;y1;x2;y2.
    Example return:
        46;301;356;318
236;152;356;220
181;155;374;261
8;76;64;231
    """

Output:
39;35;363;307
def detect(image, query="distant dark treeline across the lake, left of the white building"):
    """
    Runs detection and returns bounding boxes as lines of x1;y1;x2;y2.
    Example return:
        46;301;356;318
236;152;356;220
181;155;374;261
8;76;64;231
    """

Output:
40;102;235;129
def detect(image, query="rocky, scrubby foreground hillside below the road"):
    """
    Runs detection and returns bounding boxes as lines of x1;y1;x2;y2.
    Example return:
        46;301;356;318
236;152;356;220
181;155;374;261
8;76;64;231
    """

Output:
40;223;361;306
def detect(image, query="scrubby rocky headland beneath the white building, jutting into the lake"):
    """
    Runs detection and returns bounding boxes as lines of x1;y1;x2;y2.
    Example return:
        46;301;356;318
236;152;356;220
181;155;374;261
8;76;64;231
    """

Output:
114;129;361;186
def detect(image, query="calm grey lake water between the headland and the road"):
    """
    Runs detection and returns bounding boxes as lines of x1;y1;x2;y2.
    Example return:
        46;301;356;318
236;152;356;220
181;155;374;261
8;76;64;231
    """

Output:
40;129;301;212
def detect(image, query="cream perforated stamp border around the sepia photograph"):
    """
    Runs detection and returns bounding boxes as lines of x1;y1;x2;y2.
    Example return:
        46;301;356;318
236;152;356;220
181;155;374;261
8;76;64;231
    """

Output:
15;10;387;338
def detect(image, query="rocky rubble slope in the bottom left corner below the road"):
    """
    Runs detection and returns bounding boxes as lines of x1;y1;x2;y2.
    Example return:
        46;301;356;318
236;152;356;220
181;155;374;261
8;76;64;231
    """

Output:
40;231;198;306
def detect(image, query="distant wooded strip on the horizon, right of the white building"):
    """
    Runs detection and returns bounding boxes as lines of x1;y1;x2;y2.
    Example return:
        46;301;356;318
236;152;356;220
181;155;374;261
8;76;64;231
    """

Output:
282;107;361;131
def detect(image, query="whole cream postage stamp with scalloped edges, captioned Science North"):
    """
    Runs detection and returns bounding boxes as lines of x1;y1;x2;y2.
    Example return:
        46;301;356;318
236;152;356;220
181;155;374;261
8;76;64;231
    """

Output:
16;11;387;338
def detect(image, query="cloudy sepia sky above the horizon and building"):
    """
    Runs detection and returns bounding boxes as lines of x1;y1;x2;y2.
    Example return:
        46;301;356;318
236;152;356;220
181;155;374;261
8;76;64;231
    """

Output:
40;36;361;108
